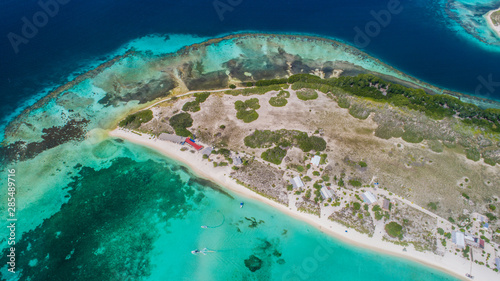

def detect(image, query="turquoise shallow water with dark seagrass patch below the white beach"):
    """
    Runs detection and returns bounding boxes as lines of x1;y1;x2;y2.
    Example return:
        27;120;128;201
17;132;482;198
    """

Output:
0;139;458;281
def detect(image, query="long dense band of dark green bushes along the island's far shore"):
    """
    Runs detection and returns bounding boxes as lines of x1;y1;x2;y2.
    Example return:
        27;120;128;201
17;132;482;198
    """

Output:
257;74;500;132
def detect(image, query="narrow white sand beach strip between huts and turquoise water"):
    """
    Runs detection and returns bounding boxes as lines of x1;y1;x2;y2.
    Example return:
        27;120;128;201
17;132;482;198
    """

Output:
109;129;500;281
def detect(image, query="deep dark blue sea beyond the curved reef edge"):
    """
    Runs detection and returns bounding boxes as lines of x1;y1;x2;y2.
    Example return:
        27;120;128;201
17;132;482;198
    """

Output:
0;0;500;132
